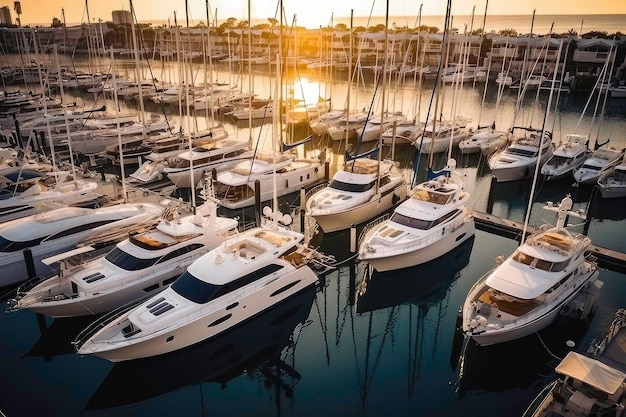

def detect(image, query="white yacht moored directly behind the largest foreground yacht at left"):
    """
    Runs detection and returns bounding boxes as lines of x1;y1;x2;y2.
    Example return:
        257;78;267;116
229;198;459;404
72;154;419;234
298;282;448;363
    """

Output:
8;201;237;318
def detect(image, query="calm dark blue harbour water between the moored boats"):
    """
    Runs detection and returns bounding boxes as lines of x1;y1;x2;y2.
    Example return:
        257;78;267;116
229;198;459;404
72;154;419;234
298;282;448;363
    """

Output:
0;56;626;417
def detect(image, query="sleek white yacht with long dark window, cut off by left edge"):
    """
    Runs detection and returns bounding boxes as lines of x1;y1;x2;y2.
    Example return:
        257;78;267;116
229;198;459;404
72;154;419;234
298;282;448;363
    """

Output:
0;203;162;286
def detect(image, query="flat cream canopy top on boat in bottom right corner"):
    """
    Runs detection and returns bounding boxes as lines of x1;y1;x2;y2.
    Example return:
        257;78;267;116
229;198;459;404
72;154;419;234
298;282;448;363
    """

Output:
556;351;626;394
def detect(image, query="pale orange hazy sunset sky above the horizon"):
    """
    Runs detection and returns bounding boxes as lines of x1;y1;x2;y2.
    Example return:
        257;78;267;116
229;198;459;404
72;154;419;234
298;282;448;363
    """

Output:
8;0;626;28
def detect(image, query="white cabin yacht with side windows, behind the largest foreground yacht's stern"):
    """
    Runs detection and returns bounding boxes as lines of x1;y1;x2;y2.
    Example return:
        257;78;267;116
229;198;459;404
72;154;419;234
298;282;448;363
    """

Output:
215;152;326;209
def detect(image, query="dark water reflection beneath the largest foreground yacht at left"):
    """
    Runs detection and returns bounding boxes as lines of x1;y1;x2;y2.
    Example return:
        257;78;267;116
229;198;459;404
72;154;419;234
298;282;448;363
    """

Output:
85;287;316;414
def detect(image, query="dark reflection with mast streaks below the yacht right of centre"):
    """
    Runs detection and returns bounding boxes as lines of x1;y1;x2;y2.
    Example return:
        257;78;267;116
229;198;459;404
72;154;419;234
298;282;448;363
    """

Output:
352;237;474;411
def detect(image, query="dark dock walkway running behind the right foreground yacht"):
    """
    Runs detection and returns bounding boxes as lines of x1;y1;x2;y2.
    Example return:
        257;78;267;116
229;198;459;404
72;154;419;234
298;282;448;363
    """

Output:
472;211;626;273
